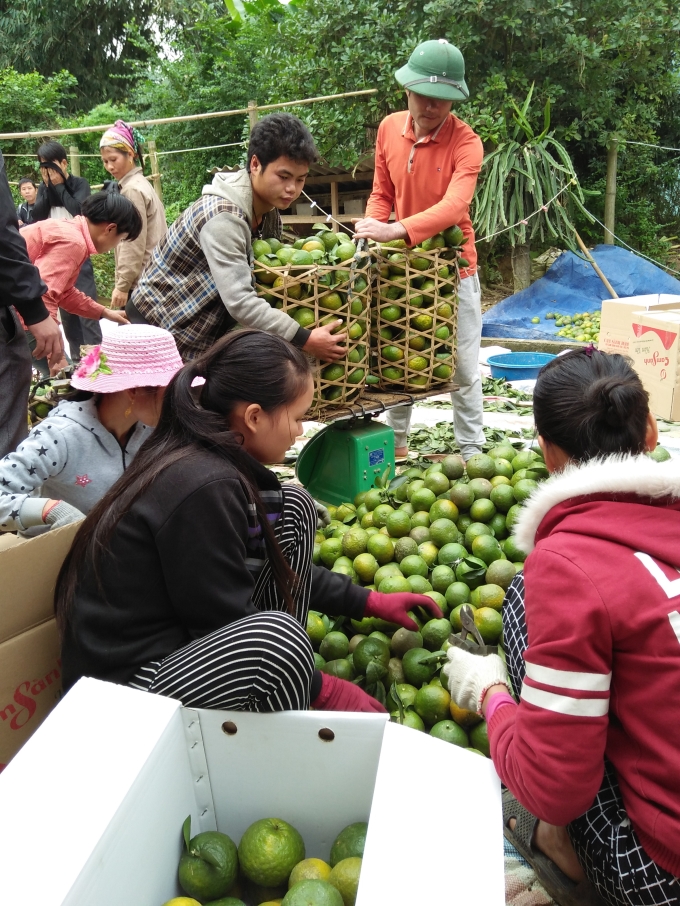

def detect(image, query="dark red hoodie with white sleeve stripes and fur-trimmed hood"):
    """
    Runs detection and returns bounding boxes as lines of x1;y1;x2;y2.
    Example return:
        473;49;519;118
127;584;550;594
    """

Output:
489;456;680;875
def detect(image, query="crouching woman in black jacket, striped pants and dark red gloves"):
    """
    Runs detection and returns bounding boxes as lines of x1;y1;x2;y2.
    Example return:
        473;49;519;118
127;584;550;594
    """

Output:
55;330;441;711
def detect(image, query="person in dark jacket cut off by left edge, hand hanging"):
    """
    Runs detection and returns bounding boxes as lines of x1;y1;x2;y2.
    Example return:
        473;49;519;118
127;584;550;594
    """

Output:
0;153;63;457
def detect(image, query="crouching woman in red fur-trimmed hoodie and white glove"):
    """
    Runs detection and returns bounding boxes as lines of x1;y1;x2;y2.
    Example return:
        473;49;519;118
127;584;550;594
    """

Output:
445;347;680;906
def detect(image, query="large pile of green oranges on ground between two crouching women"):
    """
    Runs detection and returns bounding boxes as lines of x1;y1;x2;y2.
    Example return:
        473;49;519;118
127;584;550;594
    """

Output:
307;442;548;754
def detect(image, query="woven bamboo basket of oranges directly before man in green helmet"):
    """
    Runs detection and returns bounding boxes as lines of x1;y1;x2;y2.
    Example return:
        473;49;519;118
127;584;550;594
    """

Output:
371;247;460;391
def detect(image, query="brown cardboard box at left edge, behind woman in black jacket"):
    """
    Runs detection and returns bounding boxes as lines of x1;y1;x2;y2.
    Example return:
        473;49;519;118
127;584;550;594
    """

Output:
0;523;80;770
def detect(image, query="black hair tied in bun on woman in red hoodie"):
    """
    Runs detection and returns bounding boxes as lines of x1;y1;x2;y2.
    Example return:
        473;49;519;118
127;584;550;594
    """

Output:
534;346;649;462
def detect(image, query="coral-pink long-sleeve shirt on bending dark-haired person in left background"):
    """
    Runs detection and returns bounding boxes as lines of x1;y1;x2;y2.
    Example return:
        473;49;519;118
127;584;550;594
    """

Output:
21;216;104;321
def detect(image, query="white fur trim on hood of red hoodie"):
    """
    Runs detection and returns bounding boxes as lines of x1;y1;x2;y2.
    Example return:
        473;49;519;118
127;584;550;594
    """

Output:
514;454;680;554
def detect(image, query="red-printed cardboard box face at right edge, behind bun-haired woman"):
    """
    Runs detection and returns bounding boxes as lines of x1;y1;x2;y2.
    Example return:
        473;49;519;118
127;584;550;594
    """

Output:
630;310;680;422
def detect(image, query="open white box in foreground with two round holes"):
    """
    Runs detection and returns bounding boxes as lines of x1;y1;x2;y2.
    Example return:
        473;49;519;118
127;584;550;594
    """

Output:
0;679;505;906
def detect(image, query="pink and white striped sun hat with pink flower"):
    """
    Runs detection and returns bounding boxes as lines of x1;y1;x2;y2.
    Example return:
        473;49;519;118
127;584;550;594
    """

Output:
71;324;184;393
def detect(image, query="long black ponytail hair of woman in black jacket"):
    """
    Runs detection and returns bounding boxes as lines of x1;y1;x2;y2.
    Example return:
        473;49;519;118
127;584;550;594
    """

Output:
55;330;312;633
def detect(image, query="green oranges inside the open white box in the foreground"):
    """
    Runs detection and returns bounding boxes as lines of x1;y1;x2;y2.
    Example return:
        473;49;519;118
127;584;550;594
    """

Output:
164;818;368;906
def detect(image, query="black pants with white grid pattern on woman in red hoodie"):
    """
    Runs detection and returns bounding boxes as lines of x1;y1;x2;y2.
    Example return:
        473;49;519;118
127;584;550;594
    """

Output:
503;573;680;906
